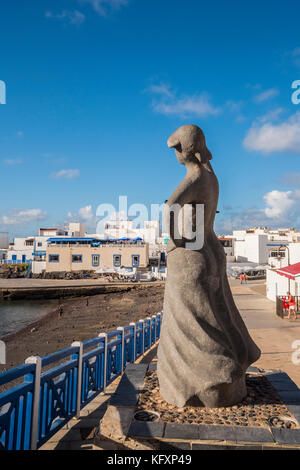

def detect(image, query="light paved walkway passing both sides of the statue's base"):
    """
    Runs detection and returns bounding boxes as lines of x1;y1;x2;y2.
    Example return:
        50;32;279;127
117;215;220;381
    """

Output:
41;281;300;450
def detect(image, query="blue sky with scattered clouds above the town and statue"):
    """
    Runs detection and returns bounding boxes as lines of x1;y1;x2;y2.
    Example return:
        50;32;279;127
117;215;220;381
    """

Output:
0;0;300;237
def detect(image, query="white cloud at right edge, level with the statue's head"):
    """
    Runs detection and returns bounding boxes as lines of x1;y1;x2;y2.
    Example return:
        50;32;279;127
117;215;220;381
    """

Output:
243;111;300;154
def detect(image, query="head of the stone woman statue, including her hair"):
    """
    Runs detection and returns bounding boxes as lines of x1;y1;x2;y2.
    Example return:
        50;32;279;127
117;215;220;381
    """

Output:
168;124;212;165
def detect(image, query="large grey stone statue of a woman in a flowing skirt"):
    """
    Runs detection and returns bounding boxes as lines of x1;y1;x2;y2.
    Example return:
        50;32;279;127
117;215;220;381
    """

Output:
157;125;260;407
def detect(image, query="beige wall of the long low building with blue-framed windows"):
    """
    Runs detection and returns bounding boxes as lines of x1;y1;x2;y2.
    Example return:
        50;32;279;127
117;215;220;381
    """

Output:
46;245;149;272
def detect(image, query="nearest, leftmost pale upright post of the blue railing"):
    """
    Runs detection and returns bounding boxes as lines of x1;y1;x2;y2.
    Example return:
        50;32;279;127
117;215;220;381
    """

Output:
25;356;42;450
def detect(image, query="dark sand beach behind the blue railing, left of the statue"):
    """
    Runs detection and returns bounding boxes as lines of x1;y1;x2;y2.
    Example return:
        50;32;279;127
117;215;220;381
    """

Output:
0;284;164;372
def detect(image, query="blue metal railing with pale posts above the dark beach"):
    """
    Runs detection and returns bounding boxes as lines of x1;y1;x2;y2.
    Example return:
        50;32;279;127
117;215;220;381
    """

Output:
0;312;162;450
